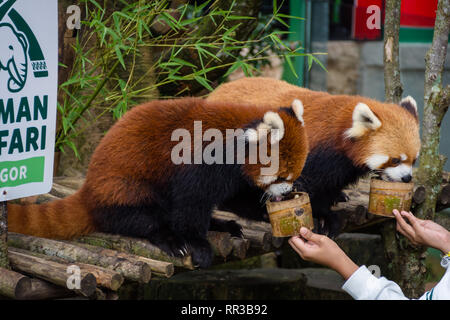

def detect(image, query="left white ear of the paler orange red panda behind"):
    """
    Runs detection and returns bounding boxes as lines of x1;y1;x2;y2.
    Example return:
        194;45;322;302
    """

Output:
344;102;381;139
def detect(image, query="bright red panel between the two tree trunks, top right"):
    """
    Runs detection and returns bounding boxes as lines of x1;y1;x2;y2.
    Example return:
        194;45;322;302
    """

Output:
400;0;438;28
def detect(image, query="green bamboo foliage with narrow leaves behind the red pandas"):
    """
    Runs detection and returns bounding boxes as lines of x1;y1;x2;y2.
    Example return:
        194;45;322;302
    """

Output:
56;0;314;156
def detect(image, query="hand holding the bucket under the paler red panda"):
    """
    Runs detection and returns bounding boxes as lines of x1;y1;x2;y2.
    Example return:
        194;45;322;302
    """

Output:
393;210;450;253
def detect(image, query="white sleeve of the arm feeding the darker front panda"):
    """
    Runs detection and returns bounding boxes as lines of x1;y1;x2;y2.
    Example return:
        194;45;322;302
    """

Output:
342;266;408;300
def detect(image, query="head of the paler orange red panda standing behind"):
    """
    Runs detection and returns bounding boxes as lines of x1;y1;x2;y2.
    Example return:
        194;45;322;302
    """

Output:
344;96;420;182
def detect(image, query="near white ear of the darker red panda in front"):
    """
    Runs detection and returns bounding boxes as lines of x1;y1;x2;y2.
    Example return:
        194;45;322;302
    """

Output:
245;111;284;144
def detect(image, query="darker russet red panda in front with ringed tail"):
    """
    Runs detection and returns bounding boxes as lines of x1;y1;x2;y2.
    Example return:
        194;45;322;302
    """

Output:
8;98;308;267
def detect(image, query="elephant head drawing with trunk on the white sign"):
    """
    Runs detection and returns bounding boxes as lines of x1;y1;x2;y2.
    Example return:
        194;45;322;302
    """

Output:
0;23;28;92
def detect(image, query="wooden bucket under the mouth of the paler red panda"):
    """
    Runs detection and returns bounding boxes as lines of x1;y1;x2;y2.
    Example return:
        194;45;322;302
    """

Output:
369;179;414;218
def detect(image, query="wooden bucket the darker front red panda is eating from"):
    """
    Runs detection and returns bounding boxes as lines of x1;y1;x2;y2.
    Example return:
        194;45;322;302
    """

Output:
266;192;314;237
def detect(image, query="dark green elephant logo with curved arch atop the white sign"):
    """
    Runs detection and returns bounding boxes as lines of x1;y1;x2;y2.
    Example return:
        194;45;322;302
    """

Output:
0;0;48;93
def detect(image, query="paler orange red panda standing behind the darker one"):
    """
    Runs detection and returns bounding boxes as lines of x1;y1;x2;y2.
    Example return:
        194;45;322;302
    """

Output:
207;77;420;236
